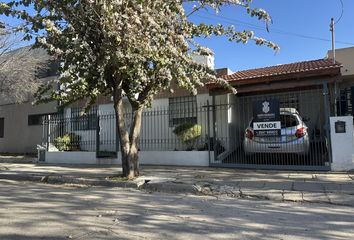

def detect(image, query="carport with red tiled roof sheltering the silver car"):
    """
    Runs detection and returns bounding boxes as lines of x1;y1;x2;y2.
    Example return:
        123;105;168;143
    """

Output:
208;59;341;170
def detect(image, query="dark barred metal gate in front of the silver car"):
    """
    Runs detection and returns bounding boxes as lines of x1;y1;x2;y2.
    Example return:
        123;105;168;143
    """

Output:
210;89;331;170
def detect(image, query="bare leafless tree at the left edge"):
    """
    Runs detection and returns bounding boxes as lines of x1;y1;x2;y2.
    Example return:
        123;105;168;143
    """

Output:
0;23;45;103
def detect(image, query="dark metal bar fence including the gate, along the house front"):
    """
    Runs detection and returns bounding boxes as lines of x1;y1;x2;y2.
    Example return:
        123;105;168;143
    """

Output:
44;89;331;170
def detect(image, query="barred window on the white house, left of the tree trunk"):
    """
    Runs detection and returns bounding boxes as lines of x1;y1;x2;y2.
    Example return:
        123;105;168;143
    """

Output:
71;106;97;131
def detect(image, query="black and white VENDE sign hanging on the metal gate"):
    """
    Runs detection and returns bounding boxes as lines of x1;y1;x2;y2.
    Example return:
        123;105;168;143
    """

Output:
253;99;281;137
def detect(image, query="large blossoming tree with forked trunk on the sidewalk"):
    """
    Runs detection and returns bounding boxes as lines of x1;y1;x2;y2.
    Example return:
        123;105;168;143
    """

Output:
0;0;277;178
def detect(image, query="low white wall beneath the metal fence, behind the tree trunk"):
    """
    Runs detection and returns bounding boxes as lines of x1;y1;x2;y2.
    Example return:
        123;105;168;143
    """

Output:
45;151;213;167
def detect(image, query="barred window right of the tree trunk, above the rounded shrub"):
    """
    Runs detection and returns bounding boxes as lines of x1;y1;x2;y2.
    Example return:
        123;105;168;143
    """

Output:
168;96;197;127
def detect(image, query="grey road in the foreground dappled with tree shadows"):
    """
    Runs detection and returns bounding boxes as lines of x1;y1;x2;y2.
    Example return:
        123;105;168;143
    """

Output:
0;180;354;240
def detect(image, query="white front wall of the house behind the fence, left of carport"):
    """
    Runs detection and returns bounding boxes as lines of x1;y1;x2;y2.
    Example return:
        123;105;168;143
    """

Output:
45;56;221;153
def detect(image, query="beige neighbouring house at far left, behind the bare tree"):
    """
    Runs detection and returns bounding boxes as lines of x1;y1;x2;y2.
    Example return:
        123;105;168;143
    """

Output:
0;49;57;153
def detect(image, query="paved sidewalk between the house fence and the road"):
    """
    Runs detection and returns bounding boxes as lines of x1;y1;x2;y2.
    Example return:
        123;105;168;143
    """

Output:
0;163;354;206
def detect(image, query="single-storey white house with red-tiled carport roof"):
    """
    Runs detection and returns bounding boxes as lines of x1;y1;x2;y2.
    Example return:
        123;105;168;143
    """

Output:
45;59;354;170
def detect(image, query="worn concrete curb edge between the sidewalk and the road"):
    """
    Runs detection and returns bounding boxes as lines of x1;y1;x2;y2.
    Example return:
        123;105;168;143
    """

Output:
0;173;354;207
